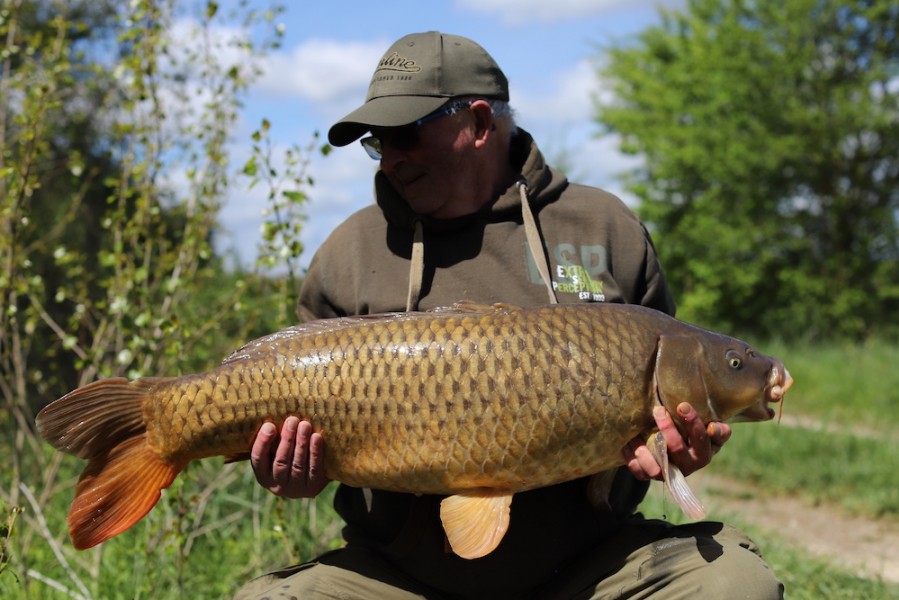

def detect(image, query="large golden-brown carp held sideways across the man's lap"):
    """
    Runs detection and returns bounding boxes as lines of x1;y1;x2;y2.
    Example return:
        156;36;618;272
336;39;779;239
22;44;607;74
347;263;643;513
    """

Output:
37;302;792;558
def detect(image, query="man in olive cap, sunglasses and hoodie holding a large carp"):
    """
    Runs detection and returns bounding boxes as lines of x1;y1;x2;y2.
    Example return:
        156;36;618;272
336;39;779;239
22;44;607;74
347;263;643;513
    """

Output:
238;32;782;598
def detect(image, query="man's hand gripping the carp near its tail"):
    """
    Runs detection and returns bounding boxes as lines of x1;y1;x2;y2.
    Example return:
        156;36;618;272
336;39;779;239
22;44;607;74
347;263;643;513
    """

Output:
250;416;330;498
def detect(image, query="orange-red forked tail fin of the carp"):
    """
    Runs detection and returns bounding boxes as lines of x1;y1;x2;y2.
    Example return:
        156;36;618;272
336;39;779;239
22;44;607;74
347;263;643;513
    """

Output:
36;378;185;550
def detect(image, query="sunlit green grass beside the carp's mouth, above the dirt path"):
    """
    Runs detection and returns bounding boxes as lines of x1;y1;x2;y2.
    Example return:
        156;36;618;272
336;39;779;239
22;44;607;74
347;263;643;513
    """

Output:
710;342;899;519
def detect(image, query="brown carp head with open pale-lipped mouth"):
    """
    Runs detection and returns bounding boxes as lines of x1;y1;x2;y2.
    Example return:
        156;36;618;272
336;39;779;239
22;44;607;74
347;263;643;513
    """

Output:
654;330;793;423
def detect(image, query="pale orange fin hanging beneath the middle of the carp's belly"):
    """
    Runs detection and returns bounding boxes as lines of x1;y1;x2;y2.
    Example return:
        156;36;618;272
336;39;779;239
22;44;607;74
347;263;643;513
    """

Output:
440;488;512;559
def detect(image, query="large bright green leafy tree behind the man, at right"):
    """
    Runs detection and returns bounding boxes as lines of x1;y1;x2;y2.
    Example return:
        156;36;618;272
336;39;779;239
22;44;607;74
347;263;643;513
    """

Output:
596;0;899;338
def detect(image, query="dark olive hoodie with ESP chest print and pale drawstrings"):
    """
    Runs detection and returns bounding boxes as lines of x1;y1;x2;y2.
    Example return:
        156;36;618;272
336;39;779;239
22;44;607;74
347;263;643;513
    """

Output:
298;129;674;597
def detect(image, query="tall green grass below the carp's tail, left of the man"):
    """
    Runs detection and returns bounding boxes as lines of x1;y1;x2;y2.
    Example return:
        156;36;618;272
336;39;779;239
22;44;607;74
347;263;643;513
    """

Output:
0;457;341;600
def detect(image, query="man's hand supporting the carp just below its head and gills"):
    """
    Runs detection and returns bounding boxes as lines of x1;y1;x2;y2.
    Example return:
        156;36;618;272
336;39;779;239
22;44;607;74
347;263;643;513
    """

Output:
623;402;731;481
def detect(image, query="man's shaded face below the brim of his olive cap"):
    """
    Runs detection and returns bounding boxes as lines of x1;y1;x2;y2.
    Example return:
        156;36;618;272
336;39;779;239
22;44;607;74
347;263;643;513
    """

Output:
372;110;489;219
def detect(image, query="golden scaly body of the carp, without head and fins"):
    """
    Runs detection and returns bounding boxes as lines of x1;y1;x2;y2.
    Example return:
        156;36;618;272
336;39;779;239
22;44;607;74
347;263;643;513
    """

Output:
145;306;656;493
